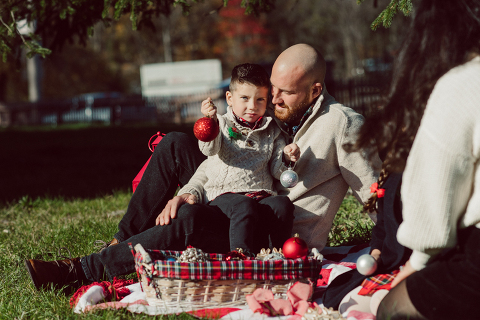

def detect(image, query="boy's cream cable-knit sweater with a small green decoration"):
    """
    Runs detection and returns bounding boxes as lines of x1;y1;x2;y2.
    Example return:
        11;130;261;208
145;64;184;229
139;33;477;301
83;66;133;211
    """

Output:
178;107;287;203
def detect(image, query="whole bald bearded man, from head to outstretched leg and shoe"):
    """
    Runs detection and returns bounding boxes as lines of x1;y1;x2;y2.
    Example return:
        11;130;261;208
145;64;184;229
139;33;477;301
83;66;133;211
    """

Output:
26;44;380;289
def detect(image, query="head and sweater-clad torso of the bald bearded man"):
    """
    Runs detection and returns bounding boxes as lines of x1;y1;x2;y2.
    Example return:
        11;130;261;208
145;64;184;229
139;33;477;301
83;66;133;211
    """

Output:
270;44;381;250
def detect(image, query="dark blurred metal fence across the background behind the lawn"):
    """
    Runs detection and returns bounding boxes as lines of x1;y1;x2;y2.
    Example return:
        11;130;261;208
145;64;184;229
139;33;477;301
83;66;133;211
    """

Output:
0;74;389;127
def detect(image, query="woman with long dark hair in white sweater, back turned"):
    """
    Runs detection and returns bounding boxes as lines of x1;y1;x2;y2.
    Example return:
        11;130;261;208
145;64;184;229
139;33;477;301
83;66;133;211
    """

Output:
346;0;480;319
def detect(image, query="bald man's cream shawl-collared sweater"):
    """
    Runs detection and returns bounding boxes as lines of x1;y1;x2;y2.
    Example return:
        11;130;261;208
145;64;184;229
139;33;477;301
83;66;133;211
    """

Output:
179;89;381;250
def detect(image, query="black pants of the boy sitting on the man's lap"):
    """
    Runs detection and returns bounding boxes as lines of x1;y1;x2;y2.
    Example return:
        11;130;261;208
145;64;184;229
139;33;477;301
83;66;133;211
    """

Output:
179;193;294;253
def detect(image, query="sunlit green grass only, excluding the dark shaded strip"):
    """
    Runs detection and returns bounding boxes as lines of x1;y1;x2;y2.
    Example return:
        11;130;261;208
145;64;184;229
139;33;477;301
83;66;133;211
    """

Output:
0;192;371;319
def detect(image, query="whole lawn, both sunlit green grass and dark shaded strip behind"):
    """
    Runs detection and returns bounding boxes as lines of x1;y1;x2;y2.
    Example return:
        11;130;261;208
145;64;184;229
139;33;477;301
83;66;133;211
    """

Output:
0;126;372;319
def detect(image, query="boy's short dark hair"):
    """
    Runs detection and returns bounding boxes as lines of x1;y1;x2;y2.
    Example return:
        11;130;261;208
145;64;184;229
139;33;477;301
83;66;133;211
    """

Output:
229;63;270;92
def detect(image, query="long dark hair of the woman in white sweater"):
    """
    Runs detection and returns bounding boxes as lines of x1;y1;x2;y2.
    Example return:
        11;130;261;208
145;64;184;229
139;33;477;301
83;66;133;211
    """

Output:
346;0;480;172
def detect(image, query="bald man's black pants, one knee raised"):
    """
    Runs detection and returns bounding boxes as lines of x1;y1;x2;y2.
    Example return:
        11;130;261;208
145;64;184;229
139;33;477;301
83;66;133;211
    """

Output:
81;132;213;281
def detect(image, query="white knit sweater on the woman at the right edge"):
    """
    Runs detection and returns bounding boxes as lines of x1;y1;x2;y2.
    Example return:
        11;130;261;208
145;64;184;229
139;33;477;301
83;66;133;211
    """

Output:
397;57;480;270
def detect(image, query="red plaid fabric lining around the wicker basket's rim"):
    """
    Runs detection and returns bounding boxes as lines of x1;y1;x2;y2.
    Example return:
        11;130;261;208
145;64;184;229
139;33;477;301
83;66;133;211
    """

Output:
135;250;321;282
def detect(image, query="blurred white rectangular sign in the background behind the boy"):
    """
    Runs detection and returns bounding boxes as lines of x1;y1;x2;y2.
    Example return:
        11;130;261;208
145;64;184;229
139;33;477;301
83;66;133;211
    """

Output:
140;59;222;97
